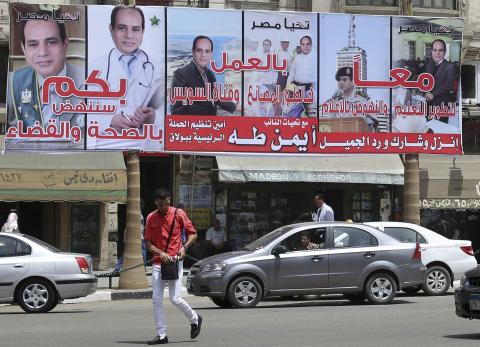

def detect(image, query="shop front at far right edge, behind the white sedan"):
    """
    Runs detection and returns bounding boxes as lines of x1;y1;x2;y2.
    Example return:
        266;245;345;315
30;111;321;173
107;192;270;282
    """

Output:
419;155;480;250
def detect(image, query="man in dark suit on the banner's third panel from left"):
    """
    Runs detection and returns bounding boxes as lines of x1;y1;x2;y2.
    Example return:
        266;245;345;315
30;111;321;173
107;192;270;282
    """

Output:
171;35;236;116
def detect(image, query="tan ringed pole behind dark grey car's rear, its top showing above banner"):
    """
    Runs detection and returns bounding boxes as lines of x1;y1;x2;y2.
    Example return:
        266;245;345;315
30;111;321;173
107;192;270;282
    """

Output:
399;0;420;224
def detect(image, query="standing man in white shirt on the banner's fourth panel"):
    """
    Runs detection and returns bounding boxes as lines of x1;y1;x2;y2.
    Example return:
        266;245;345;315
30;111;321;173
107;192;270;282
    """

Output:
287;36;317;117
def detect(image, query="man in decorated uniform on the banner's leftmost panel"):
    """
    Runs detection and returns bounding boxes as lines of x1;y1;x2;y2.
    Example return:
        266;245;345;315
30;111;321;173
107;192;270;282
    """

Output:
7;11;85;143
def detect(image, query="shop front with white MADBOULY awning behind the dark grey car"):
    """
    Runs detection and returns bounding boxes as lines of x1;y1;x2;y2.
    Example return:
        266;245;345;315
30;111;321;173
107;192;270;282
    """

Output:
214;155;404;249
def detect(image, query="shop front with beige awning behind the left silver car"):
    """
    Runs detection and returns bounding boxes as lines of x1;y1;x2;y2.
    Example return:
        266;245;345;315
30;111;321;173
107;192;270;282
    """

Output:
0;144;127;268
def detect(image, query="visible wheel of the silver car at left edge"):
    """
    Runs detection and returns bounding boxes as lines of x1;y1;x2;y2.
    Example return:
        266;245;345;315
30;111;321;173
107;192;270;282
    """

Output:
17;278;57;313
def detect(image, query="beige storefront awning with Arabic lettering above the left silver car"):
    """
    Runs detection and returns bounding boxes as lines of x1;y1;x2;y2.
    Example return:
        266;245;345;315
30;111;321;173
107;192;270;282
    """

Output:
0;141;127;202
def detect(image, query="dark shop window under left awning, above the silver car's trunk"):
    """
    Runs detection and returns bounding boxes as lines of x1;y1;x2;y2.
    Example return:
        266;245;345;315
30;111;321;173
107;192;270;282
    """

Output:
70;204;100;258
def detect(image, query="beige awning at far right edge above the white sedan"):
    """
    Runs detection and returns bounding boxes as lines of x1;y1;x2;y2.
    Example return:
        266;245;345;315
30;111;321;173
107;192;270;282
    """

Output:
419;154;480;209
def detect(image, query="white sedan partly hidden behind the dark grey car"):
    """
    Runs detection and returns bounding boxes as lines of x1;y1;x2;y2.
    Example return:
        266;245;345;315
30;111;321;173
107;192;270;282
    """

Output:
365;222;477;295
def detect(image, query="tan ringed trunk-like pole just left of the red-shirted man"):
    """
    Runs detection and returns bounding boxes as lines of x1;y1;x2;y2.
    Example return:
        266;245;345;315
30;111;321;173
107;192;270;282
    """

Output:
118;151;148;289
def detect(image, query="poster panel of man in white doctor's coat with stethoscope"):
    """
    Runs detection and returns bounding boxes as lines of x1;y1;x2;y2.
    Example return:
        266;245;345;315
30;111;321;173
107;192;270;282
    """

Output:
87;6;165;151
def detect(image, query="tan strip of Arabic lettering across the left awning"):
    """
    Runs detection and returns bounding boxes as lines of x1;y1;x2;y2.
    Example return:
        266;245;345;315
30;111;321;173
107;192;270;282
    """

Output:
0;169;126;190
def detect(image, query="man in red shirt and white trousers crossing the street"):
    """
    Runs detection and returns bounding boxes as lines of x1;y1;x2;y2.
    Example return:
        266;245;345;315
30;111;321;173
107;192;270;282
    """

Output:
145;188;202;345
